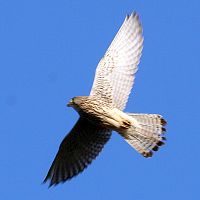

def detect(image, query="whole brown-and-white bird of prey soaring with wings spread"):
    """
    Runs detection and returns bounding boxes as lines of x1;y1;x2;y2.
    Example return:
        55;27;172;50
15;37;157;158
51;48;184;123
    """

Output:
44;12;166;186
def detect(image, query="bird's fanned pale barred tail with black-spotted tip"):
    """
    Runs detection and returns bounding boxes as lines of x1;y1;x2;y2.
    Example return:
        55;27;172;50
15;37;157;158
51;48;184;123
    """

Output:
120;113;166;157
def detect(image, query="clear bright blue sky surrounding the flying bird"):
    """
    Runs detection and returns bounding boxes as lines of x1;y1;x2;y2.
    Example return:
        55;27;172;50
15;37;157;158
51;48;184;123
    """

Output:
0;0;200;200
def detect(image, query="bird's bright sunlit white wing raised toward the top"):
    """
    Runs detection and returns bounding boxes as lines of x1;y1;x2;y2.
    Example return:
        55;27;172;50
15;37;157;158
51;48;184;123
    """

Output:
90;13;143;110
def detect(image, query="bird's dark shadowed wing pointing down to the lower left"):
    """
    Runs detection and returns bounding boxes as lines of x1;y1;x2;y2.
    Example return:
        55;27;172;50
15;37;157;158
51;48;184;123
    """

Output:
44;118;111;186
